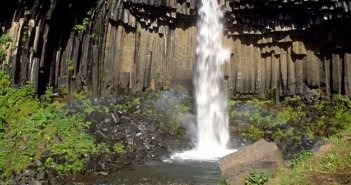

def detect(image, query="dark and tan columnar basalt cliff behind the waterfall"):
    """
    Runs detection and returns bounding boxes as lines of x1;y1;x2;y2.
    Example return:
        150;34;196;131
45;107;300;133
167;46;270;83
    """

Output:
0;0;351;96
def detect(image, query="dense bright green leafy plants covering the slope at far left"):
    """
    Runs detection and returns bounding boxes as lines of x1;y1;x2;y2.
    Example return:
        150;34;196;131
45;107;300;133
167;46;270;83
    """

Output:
0;71;97;176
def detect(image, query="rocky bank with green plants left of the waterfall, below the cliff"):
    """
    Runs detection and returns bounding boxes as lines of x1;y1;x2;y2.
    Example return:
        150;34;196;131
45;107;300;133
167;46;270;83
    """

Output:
0;72;192;184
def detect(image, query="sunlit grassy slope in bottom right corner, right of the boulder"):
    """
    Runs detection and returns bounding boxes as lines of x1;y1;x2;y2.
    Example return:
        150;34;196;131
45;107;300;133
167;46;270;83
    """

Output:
268;129;351;185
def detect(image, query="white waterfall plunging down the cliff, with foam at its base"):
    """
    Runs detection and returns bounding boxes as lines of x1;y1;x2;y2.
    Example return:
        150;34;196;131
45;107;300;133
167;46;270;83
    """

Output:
171;0;233;160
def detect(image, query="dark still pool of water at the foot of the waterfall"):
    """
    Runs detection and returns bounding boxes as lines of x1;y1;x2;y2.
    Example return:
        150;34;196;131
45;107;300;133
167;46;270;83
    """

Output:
91;161;221;185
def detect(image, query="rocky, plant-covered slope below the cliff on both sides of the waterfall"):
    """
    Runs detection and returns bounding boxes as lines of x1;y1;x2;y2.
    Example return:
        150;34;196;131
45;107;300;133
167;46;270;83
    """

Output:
0;69;351;184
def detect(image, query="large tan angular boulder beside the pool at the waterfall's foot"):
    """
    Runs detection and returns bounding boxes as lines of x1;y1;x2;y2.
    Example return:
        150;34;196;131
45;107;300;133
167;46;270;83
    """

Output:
219;139;284;185
